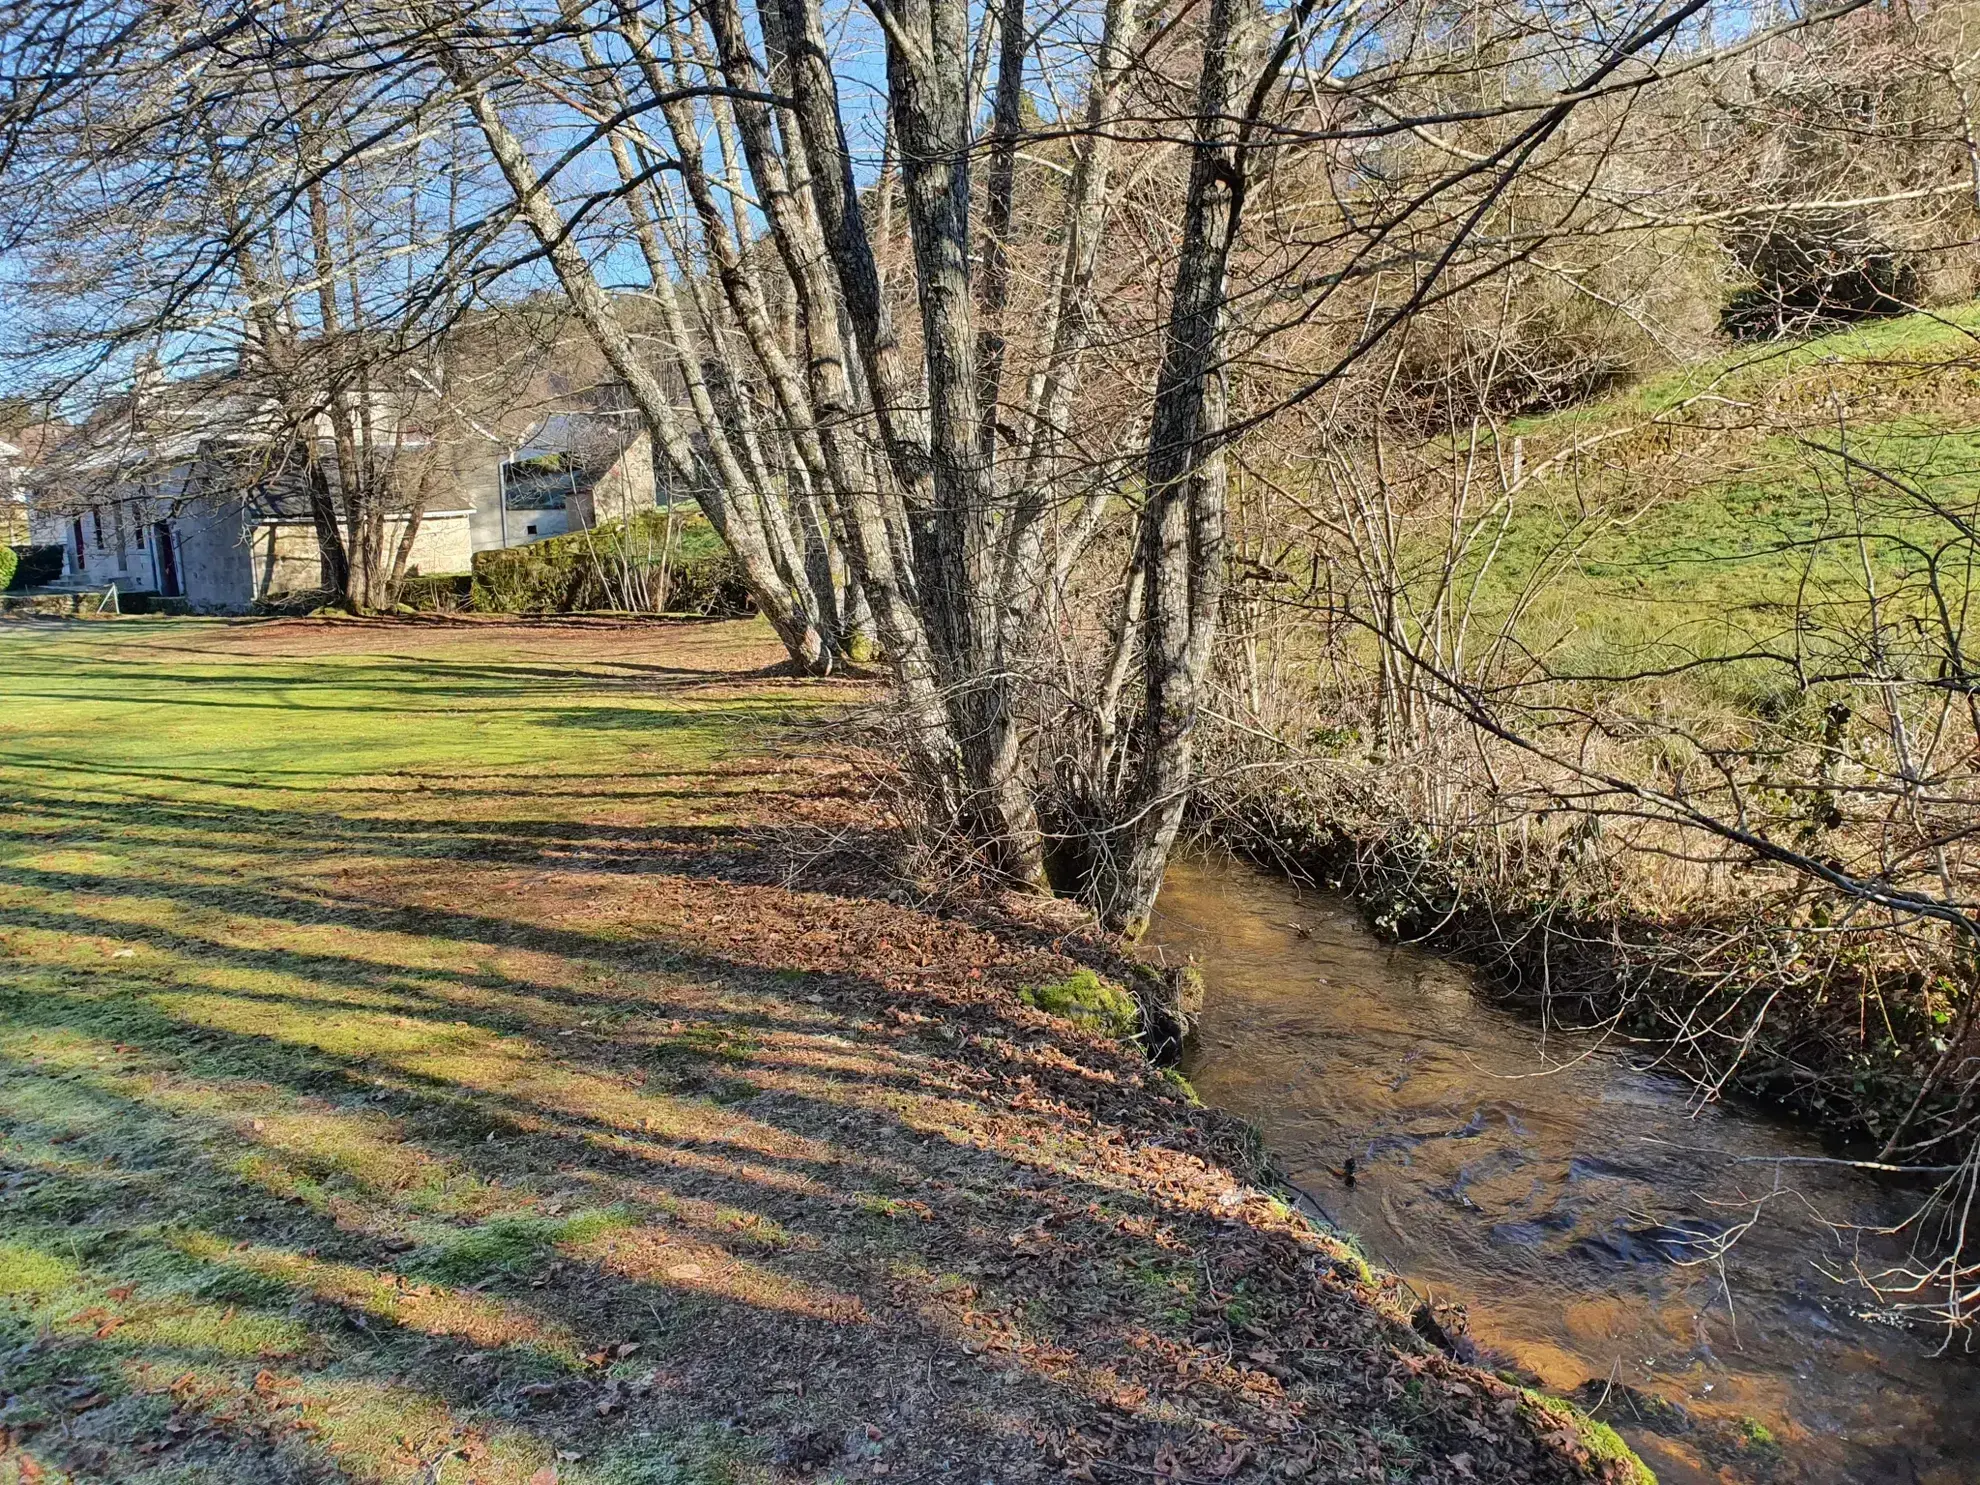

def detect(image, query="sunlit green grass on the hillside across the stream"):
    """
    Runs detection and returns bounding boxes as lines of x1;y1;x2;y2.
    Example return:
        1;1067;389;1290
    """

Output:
1457;305;1980;687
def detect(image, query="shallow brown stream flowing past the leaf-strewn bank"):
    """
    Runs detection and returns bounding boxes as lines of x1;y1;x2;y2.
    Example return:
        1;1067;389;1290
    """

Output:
1148;861;1980;1485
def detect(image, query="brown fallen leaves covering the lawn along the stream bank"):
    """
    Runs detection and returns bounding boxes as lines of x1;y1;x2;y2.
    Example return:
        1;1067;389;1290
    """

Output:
0;630;1623;1485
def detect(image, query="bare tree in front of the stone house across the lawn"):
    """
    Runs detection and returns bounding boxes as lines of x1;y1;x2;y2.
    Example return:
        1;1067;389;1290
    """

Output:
0;6;550;610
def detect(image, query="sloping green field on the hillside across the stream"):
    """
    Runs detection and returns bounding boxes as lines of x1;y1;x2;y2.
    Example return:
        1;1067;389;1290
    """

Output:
1386;307;1980;703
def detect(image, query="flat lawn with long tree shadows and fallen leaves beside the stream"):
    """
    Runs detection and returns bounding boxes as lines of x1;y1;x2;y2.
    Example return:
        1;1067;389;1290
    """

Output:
0;620;1628;1485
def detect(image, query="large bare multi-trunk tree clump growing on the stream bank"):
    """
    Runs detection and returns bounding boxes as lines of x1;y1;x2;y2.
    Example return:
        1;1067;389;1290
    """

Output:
0;0;1884;929
